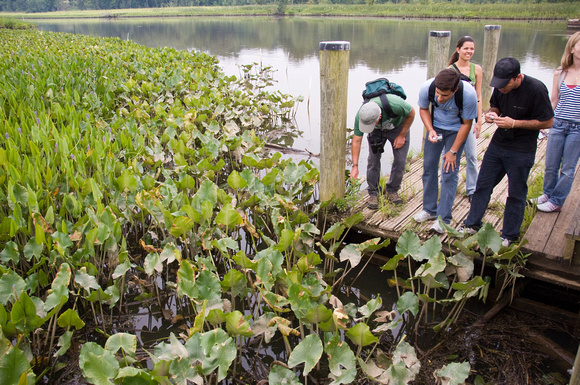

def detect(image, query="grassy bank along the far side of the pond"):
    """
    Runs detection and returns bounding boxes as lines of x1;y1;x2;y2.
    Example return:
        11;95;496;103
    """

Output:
5;2;580;20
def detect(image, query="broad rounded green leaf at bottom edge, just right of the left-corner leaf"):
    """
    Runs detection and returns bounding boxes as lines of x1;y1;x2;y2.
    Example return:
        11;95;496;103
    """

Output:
79;342;119;385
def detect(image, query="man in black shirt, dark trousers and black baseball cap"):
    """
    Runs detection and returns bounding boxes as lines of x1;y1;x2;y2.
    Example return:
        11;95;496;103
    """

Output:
463;57;554;246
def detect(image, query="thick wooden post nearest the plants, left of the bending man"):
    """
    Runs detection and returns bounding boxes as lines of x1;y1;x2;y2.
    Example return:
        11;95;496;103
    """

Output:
318;41;350;202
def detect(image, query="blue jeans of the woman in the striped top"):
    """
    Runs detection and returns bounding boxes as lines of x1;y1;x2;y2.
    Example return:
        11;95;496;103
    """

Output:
544;118;580;207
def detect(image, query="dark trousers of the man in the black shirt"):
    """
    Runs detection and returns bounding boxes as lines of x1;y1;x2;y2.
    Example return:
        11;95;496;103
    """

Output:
464;143;536;241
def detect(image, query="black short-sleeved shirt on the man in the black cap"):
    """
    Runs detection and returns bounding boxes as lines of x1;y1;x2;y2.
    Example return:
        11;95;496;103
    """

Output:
489;75;554;153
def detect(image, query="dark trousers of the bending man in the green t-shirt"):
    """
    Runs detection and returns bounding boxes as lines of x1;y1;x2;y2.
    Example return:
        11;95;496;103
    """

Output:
367;124;411;196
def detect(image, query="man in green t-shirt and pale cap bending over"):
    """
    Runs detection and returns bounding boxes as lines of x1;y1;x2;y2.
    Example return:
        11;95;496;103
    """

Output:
350;94;415;210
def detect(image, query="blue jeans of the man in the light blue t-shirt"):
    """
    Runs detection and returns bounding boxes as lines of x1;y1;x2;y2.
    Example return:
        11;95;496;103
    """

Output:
423;127;463;223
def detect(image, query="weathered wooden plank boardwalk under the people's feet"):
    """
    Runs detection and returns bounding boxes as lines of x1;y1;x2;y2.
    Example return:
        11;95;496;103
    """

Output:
329;123;580;290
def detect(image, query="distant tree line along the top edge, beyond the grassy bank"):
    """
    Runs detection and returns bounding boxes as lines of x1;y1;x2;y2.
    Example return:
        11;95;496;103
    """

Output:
0;0;576;13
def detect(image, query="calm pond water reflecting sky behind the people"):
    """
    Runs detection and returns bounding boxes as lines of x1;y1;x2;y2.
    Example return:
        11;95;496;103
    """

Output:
33;17;566;178
